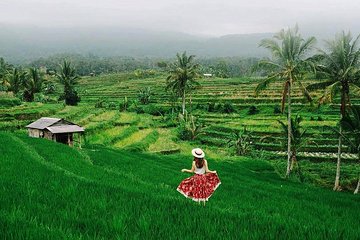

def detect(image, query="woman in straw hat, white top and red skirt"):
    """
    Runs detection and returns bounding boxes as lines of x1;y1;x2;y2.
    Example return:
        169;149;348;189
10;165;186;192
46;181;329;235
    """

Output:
177;148;221;205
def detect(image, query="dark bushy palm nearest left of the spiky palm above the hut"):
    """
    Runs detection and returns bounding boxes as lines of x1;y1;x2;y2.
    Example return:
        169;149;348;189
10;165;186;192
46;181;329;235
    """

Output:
23;68;44;102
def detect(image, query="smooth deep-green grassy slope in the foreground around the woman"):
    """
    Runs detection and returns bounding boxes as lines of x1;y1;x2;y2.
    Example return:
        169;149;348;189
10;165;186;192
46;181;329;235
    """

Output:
0;133;360;239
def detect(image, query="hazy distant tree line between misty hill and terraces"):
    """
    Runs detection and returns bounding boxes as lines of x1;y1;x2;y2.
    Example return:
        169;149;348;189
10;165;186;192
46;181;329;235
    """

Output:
27;54;259;78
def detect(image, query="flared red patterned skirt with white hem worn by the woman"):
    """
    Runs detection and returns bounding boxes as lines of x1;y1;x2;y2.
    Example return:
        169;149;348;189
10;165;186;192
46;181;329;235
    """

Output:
177;173;221;202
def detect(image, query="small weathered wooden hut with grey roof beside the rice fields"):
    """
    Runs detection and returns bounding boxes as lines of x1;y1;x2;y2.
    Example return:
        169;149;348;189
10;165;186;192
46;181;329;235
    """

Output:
26;117;84;146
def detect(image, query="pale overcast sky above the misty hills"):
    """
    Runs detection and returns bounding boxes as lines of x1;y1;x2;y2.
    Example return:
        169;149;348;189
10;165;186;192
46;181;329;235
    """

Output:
0;0;360;36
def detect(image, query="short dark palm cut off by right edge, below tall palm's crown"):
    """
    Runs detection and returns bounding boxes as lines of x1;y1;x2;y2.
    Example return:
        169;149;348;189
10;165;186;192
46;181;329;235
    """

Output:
340;106;360;194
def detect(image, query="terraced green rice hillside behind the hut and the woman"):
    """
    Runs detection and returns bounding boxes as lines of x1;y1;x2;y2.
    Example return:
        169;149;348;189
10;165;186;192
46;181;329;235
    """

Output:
0;72;360;191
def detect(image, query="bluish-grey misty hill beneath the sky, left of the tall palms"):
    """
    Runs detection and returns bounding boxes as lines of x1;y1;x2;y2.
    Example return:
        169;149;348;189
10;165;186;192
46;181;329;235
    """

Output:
0;25;272;63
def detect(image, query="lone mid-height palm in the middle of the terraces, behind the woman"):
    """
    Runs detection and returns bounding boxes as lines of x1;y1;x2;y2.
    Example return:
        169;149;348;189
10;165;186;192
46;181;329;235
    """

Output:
166;52;199;115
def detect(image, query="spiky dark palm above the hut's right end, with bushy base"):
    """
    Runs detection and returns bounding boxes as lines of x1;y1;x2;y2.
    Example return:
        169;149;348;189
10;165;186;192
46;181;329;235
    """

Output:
56;60;80;105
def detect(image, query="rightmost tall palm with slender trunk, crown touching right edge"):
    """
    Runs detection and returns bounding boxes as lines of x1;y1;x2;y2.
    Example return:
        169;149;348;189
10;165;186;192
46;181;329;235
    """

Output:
307;32;360;190
